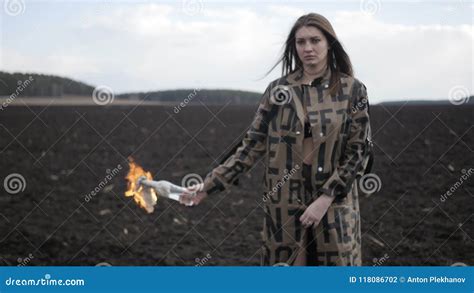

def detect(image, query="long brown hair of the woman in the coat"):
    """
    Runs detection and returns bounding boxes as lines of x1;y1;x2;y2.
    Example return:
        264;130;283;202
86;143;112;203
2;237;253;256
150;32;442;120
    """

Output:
267;13;354;95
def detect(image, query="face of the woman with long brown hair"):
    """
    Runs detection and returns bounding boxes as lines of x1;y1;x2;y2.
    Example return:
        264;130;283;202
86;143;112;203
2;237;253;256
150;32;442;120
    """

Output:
295;26;329;67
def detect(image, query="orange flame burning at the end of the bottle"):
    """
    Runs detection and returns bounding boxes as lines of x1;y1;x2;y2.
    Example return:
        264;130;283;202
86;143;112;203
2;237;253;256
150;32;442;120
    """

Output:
125;157;157;213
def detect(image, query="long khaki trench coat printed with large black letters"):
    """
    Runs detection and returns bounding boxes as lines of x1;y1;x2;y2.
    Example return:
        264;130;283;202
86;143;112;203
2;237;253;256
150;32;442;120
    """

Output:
203;67;372;266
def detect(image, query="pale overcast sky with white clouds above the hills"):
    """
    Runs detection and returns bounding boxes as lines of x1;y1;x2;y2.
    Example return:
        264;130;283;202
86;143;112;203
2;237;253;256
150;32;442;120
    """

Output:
0;0;474;103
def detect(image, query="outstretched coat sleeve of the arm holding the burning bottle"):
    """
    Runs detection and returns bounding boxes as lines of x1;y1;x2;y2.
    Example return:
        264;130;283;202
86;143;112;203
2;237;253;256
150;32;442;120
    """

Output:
202;85;274;194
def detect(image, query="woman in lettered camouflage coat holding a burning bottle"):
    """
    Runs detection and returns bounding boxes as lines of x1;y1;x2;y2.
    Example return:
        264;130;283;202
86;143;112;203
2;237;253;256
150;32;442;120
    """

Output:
182;13;372;266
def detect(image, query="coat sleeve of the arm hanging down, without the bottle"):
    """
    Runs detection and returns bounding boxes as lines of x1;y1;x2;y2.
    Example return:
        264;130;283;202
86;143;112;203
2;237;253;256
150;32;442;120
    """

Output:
320;81;372;198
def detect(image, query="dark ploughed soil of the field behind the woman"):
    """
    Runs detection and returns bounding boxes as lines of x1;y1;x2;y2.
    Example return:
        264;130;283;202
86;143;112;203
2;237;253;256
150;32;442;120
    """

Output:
0;105;474;265
